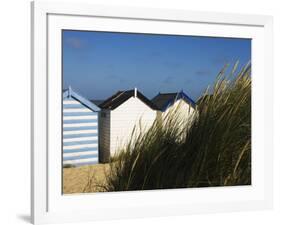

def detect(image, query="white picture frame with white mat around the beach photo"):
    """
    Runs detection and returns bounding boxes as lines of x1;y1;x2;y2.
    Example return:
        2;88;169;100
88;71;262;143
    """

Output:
31;1;273;224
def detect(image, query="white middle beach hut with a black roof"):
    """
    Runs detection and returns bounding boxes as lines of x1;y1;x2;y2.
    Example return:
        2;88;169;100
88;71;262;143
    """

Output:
99;88;157;162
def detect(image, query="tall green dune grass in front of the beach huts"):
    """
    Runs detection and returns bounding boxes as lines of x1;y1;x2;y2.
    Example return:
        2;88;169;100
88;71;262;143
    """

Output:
100;64;251;191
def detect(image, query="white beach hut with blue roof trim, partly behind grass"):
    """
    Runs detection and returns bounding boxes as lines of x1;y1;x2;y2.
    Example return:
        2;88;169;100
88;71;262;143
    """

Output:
151;91;196;121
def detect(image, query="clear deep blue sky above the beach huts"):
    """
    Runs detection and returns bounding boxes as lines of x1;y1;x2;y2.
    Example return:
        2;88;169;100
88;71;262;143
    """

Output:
62;31;251;100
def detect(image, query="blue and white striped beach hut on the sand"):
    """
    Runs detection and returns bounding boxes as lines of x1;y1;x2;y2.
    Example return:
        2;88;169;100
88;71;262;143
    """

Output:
63;87;100;166
